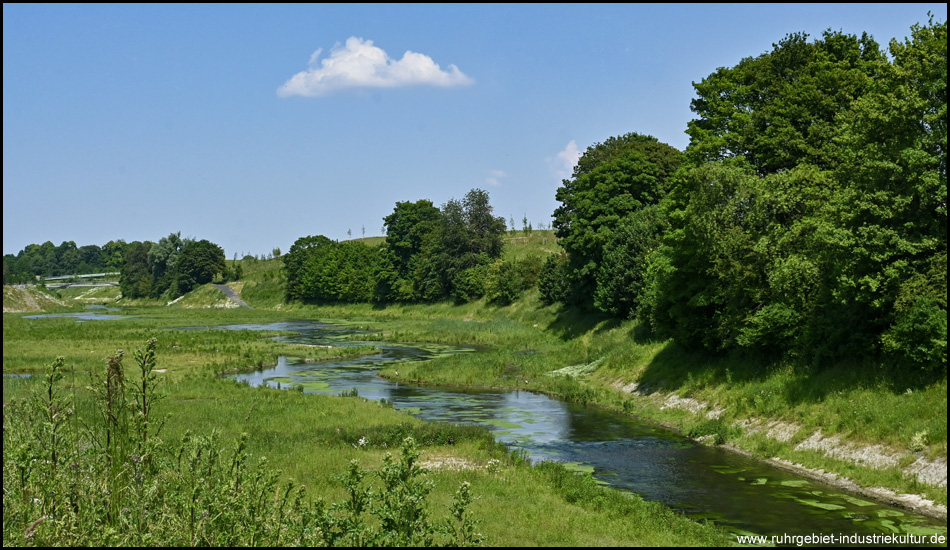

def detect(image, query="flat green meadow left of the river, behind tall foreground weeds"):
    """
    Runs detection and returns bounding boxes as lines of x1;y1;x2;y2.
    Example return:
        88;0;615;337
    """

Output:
3;298;731;546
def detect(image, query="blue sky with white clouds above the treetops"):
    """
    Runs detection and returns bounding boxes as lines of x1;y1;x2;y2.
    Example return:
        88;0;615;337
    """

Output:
3;3;947;258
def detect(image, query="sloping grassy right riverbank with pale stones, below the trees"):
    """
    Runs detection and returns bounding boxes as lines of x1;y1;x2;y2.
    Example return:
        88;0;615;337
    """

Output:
292;298;947;519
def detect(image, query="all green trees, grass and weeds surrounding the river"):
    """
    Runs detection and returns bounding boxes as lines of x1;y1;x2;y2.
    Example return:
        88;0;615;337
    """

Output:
4;12;947;546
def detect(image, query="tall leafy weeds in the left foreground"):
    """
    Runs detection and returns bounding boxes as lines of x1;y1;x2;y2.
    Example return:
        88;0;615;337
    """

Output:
3;339;483;547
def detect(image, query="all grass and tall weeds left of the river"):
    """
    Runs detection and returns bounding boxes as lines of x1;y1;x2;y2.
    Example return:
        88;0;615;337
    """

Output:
4;310;728;546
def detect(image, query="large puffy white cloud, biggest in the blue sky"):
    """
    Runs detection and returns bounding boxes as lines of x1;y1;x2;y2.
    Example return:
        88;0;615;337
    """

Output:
277;36;474;97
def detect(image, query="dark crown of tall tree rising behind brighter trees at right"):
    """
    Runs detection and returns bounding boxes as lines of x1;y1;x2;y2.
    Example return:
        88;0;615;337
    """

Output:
686;30;884;175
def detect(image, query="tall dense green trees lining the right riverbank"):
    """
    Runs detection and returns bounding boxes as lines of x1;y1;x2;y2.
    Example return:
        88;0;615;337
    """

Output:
539;18;947;371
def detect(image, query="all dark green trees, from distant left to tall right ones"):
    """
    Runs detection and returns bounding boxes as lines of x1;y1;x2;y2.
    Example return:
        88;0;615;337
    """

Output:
4;17;947;371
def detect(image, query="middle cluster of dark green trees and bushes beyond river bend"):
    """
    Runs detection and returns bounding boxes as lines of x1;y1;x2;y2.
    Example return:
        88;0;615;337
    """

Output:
283;189;541;304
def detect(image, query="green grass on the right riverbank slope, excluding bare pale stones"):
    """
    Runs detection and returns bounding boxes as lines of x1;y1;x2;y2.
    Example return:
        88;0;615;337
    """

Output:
219;254;947;503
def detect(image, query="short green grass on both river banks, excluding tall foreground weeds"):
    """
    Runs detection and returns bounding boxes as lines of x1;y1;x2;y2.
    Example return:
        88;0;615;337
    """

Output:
4;246;947;546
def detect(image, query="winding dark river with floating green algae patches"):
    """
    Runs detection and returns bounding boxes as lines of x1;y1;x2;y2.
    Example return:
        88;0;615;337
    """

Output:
215;321;947;536
